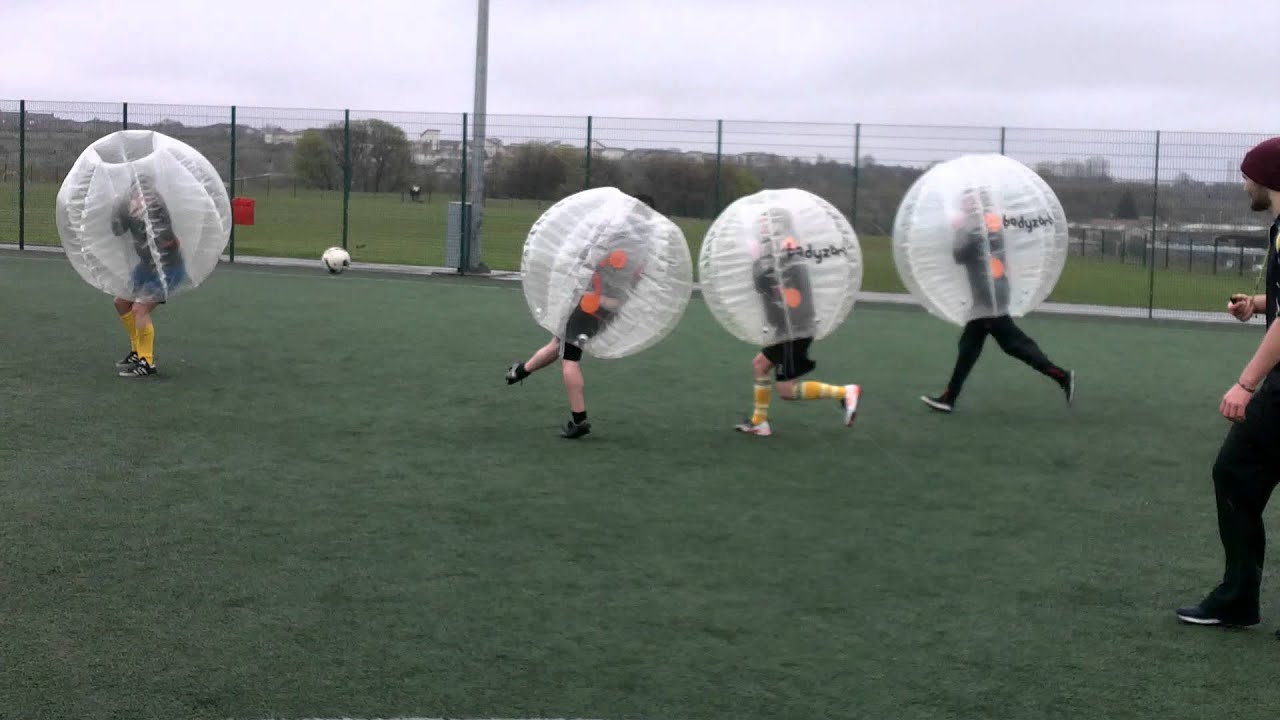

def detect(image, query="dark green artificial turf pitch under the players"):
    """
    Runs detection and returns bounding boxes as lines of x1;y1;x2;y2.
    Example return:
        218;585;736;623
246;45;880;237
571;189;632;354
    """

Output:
0;248;1280;720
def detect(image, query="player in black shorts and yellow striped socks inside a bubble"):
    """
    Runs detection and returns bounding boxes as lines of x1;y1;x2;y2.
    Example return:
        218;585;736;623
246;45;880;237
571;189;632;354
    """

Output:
733;208;861;436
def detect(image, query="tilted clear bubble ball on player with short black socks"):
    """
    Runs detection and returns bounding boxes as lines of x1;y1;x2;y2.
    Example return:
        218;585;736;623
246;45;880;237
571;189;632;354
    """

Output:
520;187;694;359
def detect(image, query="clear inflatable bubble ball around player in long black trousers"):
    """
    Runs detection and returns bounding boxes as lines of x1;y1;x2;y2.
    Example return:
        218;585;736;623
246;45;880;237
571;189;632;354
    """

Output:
893;154;1068;325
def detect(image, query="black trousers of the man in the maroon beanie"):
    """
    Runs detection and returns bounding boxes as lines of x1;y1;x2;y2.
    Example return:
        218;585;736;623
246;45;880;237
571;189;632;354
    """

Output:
1210;373;1280;609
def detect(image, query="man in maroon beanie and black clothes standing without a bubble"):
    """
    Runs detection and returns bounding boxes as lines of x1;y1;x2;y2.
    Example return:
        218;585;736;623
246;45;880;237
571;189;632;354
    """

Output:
1178;137;1280;627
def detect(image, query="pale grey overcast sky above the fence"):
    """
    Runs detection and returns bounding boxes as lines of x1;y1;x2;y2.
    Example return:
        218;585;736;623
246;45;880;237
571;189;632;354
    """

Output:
0;0;1280;132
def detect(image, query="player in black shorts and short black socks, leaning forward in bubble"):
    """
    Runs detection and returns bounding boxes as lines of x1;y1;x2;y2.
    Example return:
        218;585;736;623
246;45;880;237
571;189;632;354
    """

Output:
506;193;655;439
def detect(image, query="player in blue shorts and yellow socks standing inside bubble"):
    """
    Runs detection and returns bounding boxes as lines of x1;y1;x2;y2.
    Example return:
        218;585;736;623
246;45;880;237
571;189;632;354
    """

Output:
111;176;187;378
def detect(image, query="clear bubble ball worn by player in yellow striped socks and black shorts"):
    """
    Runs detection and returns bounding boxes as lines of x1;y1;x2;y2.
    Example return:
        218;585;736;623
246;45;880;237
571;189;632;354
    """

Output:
698;188;863;347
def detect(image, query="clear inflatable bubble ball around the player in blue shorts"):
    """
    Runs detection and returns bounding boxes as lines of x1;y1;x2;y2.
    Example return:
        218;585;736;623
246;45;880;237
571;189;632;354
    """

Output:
56;129;232;301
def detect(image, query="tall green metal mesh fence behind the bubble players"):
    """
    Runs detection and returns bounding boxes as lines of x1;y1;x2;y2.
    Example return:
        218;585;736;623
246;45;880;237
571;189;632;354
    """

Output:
0;100;1268;315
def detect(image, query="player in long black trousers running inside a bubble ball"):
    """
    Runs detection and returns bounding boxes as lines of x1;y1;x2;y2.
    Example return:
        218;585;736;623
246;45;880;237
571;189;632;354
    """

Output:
920;188;1075;413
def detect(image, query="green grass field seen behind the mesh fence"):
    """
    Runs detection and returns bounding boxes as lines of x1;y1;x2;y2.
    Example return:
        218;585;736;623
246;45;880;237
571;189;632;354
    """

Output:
0;183;1253;313
